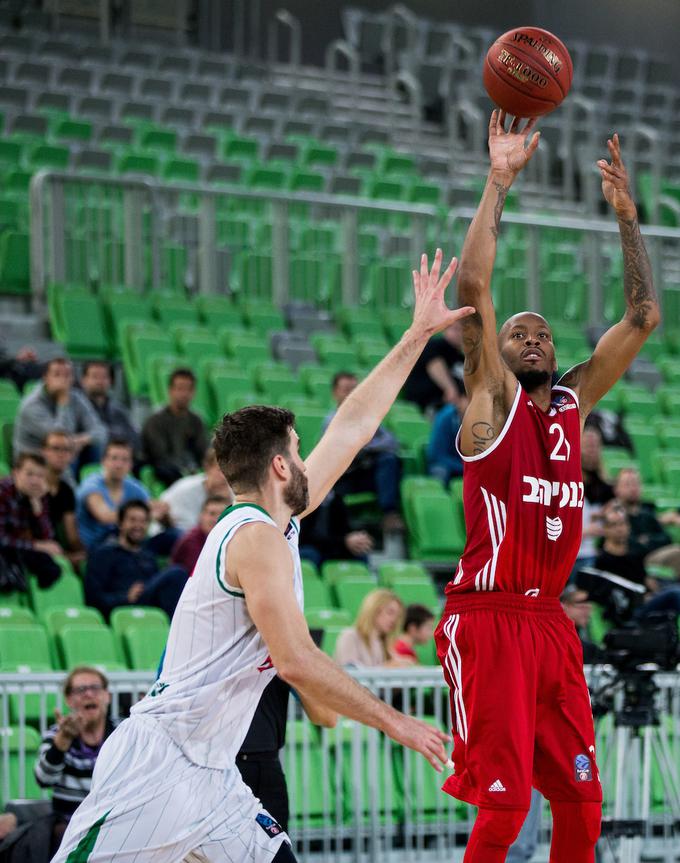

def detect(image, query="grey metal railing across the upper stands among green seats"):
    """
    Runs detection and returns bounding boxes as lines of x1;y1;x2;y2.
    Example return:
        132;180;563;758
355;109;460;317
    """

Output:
31;171;680;324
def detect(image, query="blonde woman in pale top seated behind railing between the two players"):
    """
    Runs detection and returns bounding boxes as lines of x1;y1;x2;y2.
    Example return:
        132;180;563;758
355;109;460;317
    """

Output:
335;588;411;668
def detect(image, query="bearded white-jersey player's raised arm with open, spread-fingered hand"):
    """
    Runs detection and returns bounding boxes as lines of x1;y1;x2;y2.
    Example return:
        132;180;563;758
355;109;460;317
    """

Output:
303;249;474;516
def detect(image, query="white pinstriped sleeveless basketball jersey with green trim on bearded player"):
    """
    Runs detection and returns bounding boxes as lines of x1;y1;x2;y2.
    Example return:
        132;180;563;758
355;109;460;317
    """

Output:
131;503;303;768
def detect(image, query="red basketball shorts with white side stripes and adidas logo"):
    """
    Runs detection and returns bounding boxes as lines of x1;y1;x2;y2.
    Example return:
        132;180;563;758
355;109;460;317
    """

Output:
435;592;602;809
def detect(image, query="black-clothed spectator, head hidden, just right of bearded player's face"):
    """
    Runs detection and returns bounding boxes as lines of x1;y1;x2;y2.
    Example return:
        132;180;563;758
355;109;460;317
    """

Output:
300;489;374;567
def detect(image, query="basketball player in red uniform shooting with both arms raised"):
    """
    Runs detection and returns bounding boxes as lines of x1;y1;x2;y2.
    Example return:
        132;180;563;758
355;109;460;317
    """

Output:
435;111;660;863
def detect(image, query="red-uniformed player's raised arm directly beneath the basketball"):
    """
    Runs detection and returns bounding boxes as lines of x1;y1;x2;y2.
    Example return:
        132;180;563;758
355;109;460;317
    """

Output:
458;110;539;456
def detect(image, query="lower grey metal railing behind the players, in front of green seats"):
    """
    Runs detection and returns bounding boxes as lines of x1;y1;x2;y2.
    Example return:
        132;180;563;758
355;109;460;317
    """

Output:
0;667;680;863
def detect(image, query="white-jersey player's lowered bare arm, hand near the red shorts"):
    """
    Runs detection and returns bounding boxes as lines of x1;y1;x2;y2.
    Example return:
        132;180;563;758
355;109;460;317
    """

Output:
228;523;449;770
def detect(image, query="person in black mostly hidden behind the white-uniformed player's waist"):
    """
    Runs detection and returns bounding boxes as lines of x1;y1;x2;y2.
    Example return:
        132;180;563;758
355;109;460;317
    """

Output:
236;677;337;832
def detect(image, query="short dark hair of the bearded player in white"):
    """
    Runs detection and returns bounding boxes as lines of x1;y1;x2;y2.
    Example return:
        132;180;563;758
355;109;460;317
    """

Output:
214;405;295;494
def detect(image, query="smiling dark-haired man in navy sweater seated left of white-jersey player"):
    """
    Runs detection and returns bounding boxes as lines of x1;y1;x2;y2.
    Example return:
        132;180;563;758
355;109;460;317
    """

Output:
85;500;187;619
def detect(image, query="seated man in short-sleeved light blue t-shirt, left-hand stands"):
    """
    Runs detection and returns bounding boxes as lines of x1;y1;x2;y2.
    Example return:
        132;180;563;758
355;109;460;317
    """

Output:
76;438;177;553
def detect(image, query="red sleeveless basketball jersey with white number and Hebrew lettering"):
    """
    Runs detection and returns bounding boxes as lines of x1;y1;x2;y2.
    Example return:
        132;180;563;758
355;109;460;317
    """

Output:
446;385;583;596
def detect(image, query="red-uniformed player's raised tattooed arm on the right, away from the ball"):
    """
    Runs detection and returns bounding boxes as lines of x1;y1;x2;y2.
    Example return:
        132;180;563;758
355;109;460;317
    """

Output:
561;134;661;418
